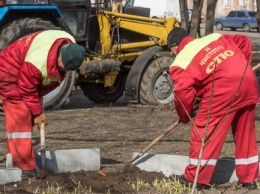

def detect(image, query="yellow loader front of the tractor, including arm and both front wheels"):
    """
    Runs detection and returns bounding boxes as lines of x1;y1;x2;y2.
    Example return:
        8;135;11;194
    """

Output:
77;0;179;104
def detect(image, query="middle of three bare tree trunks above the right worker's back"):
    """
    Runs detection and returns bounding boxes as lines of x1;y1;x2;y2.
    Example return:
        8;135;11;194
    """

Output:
190;0;204;37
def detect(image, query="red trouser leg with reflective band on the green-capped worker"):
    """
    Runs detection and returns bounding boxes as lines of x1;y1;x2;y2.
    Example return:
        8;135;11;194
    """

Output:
2;98;35;170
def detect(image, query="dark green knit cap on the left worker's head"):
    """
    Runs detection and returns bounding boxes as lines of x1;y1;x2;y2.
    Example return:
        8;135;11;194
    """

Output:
61;43;85;71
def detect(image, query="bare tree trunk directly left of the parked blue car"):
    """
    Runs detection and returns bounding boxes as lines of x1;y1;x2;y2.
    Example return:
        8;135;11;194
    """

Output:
205;0;217;35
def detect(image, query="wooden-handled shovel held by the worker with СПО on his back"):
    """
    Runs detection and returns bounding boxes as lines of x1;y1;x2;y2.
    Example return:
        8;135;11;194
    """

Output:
125;120;180;166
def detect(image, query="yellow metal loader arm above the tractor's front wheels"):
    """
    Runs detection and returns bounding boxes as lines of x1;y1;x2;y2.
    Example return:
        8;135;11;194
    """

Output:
98;10;179;58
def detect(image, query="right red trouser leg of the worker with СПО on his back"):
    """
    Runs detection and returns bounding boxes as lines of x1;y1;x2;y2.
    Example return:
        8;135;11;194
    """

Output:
232;105;259;183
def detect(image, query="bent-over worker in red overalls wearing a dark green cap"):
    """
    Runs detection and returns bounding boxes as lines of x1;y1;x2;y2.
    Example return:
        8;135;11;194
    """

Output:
0;30;85;177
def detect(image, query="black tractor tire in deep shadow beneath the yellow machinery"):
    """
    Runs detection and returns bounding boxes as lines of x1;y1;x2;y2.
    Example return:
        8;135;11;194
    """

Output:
80;73;127;104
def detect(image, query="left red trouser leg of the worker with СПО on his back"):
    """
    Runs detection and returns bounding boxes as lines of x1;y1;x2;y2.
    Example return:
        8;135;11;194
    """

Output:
184;113;235;184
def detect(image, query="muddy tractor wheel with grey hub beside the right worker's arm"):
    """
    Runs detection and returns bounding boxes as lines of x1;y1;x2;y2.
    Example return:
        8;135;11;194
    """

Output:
140;56;174;105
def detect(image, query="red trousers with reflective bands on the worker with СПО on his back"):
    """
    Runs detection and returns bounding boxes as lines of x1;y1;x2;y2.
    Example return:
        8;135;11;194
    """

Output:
184;105;259;184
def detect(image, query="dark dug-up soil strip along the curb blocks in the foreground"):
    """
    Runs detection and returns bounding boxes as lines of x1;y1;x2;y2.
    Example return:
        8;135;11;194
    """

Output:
0;166;167;194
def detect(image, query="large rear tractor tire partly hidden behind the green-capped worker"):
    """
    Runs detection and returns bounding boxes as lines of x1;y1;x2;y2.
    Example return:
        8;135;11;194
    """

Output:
0;18;75;110
